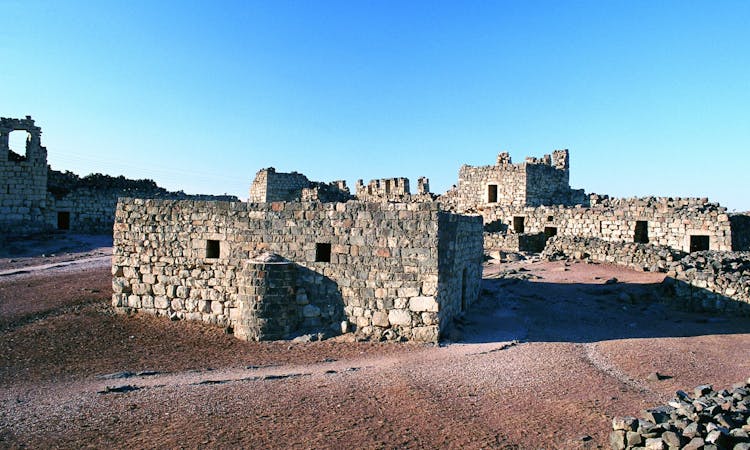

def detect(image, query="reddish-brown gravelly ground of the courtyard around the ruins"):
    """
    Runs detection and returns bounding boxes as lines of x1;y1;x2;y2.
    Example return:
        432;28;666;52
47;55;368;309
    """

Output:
0;237;750;449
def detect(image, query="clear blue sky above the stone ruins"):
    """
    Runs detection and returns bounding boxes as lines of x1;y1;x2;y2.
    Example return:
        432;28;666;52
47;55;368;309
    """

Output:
0;0;750;210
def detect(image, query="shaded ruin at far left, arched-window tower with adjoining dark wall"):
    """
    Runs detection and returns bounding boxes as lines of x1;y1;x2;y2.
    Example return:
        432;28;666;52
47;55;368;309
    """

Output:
0;116;237;242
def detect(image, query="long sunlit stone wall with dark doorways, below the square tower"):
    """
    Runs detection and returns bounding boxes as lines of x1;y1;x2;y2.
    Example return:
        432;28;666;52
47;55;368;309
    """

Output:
480;197;732;252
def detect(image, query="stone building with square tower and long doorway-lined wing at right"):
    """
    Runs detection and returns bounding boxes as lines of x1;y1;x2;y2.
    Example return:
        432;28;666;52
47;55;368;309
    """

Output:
440;150;750;252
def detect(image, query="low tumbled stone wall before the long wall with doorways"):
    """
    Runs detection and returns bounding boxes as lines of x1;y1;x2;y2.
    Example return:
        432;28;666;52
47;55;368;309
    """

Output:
542;236;685;272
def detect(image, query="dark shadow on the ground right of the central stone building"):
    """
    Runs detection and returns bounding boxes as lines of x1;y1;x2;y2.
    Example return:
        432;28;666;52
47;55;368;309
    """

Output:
461;279;750;343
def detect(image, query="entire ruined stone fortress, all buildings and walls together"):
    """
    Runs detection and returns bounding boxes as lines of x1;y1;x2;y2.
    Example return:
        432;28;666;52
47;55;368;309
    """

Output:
0;117;750;342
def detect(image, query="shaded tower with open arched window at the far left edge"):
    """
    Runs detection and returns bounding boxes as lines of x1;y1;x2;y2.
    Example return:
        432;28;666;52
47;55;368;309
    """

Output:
0;116;49;234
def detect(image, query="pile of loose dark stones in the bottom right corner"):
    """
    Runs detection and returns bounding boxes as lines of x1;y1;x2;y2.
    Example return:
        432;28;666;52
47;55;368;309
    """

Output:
609;379;750;450
